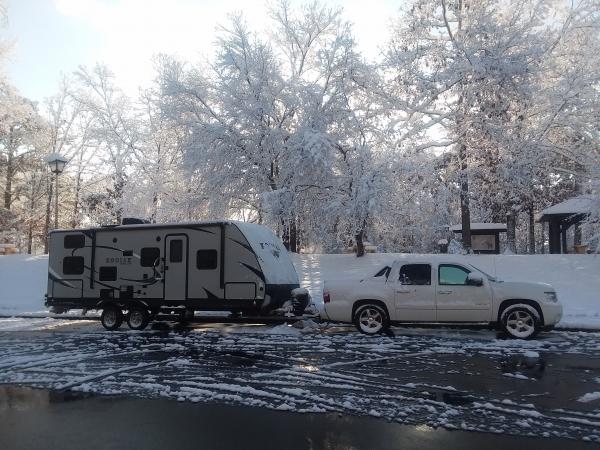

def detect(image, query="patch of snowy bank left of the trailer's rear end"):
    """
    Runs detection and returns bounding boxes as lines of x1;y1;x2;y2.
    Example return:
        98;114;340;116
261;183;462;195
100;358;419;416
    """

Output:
0;255;48;315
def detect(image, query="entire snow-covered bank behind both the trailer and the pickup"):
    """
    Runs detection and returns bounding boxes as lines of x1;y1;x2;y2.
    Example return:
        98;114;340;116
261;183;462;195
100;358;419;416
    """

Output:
0;253;600;329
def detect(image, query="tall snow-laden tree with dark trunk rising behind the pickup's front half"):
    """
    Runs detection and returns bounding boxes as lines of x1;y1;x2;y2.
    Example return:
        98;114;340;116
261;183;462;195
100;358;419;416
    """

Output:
384;0;597;253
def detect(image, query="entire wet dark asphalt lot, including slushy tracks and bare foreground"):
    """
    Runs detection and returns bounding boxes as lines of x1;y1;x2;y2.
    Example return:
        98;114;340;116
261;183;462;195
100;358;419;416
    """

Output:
0;323;600;449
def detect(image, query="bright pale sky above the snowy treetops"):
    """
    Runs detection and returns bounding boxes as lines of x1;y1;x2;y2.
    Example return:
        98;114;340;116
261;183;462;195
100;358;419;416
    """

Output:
0;0;402;101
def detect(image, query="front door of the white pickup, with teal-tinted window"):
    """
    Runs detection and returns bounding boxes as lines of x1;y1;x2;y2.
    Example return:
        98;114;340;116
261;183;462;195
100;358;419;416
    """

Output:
436;264;492;322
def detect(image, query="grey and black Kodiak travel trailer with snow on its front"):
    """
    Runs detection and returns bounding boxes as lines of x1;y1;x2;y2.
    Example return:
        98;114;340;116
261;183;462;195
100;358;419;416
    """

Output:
45;219;309;330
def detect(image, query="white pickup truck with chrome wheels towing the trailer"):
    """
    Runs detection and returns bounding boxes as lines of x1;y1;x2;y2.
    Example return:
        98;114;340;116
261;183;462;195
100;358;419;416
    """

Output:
322;256;562;339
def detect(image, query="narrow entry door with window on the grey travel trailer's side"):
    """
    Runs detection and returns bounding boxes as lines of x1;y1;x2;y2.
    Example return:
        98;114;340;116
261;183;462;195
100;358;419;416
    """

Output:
164;234;188;300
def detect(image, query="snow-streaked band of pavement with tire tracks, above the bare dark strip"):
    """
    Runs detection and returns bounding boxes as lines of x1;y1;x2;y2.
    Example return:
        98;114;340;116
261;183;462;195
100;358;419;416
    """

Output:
0;323;600;442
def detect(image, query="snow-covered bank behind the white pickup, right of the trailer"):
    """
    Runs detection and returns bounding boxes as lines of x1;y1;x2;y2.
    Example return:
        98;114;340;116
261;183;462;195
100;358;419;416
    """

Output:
294;253;600;329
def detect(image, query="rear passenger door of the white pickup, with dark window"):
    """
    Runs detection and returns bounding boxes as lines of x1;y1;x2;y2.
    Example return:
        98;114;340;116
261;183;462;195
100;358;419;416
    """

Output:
394;264;435;322
